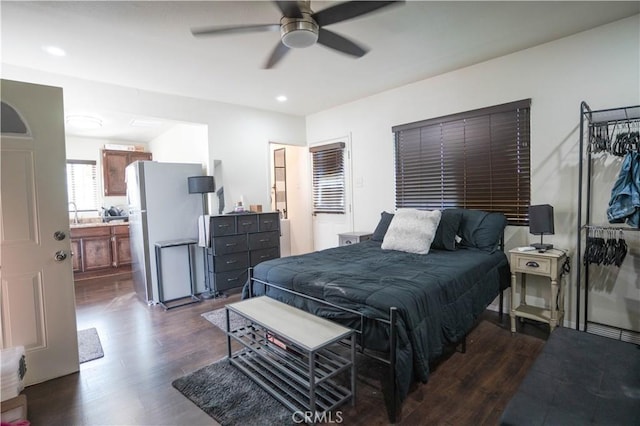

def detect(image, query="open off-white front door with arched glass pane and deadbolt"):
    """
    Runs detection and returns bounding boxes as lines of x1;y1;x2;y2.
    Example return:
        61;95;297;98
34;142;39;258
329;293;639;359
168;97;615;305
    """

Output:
0;80;79;385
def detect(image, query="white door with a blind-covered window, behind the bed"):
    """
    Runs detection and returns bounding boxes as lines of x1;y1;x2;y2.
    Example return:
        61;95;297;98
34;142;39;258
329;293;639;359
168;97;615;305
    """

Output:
309;136;353;250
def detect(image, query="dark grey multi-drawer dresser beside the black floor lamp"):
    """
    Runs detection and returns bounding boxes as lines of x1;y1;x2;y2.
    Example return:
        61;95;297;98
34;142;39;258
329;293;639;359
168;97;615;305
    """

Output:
207;213;280;291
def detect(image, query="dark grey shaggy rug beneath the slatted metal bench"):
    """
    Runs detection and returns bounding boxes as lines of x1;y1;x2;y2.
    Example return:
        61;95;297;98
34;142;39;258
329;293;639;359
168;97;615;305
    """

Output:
172;358;295;426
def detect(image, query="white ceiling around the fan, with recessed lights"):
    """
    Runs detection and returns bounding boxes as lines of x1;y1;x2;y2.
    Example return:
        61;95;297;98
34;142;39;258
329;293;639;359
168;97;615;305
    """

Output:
0;0;640;140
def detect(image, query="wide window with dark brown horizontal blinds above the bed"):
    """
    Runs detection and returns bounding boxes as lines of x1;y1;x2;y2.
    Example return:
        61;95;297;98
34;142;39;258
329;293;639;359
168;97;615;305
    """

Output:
393;99;531;225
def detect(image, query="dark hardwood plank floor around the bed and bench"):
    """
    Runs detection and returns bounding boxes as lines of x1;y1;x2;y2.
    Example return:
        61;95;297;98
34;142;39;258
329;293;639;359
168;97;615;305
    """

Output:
25;276;547;426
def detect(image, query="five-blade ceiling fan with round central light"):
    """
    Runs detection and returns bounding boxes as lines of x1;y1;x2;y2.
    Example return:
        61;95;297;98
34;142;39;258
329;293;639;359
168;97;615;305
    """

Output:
191;0;404;68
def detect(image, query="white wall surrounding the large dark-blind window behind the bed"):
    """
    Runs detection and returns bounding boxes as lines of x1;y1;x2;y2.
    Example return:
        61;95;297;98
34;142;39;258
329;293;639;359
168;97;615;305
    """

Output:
307;15;640;325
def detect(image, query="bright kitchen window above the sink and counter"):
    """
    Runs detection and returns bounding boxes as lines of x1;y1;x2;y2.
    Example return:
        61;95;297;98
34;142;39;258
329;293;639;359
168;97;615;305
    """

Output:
67;160;98;211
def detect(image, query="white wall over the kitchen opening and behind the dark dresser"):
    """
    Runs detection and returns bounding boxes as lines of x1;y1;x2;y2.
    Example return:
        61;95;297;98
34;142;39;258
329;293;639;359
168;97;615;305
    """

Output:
2;64;306;218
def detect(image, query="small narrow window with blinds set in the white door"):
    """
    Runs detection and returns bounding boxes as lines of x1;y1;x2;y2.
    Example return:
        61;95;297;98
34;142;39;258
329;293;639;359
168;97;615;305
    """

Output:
309;142;345;214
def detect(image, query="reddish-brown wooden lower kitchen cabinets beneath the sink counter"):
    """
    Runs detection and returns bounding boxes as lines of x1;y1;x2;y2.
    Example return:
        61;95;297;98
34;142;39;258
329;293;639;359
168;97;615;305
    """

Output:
71;224;131;279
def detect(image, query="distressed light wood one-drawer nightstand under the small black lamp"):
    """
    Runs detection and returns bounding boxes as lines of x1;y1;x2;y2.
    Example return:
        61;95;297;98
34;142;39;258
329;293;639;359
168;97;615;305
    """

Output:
509;249;567;333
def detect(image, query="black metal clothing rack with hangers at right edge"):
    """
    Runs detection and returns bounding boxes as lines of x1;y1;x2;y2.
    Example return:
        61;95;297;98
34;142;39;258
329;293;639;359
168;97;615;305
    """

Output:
576;101;640;331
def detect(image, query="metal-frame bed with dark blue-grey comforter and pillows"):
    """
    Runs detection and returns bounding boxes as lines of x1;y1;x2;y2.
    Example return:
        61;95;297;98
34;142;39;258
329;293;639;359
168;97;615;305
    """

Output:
244;209;510;422
